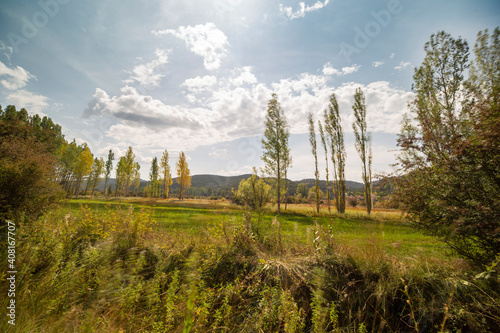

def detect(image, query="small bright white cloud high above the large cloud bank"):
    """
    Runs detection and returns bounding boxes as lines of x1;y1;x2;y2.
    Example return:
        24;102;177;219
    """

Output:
152;22;229;70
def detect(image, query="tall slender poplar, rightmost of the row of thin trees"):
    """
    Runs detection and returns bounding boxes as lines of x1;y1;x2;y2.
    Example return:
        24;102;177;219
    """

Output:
352;88;373;214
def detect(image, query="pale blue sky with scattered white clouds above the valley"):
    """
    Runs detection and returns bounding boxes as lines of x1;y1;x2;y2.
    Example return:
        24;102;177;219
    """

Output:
0;0;500;181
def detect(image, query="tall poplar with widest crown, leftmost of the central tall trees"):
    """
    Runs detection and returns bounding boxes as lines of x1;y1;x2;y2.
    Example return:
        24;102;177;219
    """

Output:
262;94;292;214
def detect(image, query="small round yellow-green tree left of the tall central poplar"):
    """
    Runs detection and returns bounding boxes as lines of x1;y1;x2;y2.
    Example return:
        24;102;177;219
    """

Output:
235;168;271;212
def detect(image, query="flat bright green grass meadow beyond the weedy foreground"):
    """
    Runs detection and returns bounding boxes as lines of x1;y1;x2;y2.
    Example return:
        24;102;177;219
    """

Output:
63;198;450;260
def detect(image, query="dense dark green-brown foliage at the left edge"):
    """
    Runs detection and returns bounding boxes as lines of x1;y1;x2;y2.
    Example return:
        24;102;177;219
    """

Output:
0;105;63;221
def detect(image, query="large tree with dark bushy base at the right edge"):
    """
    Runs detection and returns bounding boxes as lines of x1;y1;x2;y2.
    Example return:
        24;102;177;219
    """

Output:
395;28;500;265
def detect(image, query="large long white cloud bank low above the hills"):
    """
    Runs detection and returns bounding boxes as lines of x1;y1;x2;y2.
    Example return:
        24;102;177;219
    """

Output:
84;60;413;154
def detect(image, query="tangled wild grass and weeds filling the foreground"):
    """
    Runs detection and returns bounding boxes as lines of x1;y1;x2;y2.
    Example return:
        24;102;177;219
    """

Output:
0;202;500;332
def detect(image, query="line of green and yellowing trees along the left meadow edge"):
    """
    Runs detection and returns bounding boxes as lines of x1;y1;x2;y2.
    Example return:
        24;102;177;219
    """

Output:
0;105;195;220
